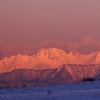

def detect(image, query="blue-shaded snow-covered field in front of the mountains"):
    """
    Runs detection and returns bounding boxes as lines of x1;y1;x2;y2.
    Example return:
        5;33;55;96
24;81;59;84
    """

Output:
0;81;100;100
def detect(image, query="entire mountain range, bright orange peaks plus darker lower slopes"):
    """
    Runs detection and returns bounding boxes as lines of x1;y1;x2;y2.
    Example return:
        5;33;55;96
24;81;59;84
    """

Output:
0;48;100;87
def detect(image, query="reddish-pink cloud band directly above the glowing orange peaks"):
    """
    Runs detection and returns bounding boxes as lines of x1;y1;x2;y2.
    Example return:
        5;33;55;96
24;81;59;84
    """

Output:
0;35;100;59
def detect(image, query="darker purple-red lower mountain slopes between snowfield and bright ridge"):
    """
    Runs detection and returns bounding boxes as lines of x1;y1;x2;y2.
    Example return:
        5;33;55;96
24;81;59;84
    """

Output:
0;65;100;87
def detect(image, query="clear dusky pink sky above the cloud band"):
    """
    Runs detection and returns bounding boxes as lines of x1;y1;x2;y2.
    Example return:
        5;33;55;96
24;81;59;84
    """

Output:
0;0;100;44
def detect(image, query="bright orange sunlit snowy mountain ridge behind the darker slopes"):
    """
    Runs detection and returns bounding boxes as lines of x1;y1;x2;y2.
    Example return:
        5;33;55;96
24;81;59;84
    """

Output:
0;47;100;73
